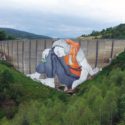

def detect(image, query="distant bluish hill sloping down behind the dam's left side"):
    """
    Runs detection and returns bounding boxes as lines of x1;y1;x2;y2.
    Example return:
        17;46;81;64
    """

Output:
0;28;50;39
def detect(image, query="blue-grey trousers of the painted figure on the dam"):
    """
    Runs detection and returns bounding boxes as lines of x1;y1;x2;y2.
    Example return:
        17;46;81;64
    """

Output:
36;49;79;88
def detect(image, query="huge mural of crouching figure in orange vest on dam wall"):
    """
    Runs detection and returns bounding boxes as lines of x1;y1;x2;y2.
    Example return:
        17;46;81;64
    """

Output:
27;39;99;91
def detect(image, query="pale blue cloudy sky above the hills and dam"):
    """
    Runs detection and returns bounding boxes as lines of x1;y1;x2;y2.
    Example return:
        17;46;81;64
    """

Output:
0;0;125;38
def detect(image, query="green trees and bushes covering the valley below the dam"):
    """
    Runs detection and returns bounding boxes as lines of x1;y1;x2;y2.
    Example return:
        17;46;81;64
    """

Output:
0;52;125;125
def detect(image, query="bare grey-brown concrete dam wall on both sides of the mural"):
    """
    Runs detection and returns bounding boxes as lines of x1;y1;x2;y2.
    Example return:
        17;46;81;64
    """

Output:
0;39;125;74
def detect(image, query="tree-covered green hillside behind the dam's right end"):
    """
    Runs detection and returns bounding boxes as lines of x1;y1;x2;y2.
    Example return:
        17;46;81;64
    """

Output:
81;24;125;39
